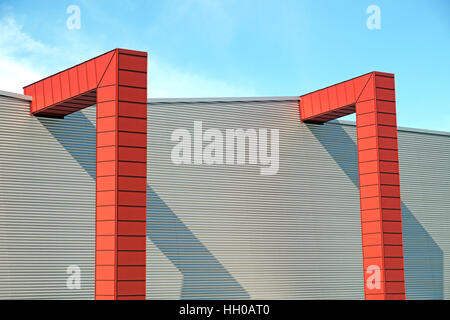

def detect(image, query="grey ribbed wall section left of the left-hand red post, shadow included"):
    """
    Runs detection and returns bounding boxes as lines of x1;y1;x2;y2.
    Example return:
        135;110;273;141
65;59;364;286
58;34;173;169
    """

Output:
0;96;95;299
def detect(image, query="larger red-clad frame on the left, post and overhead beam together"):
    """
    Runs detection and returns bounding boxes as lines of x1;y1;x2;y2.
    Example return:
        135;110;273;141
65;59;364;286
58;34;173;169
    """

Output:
24;49;147;300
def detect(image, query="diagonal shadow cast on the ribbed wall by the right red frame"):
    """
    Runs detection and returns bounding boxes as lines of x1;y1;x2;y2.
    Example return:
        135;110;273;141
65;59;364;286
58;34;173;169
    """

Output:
308;122;444;300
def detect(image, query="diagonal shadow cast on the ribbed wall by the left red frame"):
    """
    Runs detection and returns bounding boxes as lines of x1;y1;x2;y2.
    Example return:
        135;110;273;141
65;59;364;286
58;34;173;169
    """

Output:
38;112;250;299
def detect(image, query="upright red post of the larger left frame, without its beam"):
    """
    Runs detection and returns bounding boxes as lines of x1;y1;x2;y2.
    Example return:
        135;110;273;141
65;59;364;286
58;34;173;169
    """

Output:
95;49;147;299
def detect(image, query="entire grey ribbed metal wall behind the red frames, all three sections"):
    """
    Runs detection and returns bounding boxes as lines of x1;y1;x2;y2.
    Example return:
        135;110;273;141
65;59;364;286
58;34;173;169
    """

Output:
0;97;450;299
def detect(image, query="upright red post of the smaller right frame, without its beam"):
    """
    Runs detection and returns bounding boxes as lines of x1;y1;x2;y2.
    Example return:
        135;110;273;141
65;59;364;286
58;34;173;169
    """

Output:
356;72;405;300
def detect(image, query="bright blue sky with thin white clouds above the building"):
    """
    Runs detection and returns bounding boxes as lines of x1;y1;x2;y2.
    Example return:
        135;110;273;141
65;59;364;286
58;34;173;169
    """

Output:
0;0;450;131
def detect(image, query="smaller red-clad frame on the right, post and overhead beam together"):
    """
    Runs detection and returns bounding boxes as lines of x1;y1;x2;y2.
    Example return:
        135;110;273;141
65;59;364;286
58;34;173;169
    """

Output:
300;72;405;300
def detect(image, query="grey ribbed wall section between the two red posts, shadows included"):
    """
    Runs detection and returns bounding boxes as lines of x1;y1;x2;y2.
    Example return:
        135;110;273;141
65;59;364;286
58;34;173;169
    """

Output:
147;100;364;299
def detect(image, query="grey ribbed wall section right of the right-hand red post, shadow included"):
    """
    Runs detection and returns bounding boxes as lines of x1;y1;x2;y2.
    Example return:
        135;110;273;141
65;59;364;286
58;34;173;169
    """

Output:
398;130;450;300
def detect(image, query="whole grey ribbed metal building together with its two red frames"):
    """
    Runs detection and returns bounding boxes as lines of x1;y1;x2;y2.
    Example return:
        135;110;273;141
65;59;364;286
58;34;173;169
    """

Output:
0;49;450;299
